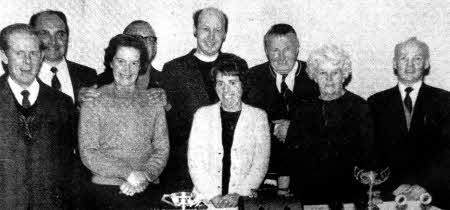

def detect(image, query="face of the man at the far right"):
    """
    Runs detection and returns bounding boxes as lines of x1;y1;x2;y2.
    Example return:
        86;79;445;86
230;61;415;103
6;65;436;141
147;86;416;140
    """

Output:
394;43;428;84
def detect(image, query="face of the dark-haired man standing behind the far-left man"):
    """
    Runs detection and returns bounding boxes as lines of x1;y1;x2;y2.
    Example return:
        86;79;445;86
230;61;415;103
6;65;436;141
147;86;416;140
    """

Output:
34;14;69;62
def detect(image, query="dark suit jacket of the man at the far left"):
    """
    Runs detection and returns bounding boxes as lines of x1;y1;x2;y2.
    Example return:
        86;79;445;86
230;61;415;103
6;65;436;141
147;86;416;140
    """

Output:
0;75;75;209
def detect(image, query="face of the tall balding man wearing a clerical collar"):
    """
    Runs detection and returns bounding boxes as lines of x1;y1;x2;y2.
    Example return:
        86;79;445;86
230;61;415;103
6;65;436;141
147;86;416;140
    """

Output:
195;10;226;56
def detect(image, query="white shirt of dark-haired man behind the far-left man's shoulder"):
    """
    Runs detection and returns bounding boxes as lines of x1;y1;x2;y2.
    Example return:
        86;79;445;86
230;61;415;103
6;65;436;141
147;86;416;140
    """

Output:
39;59;75;102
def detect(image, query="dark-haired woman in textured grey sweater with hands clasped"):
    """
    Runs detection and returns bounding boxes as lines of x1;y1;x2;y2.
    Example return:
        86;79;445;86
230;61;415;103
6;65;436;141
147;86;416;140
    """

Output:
79;34;169;209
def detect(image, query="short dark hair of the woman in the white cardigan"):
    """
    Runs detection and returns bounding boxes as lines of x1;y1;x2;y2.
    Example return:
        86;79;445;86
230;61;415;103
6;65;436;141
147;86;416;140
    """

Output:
210;54;247;89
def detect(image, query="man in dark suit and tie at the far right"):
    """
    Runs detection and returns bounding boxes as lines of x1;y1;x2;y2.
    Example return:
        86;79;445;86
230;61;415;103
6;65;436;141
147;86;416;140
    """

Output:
368;37;450;209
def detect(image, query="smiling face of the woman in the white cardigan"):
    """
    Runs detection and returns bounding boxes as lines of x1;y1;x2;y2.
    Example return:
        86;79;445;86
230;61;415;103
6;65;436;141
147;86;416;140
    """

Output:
216;72;242;112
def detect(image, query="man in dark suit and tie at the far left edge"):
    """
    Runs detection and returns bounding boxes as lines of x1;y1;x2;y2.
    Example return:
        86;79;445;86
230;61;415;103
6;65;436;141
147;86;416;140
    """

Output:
0;24;75;209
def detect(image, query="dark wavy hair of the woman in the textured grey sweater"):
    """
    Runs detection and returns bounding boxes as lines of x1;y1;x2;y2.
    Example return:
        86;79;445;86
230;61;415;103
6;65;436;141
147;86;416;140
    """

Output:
103;34;148;75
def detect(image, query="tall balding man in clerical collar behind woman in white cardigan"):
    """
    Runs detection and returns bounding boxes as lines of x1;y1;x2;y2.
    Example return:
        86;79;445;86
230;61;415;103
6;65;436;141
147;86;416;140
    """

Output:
161;8;248;192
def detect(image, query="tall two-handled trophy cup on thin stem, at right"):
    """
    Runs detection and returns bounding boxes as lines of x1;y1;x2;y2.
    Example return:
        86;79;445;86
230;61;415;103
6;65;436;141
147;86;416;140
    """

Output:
354;166;390;210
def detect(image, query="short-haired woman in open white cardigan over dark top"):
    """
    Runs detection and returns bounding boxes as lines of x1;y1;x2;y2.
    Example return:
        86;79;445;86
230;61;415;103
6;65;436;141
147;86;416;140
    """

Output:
188;56;270;208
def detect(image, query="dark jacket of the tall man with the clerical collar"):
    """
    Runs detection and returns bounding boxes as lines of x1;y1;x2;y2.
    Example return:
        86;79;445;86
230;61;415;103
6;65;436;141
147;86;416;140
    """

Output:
161;49;248;191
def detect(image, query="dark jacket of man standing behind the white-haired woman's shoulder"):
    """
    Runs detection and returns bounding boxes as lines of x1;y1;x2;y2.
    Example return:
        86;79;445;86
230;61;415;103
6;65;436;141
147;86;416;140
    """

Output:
243;61;319;121
